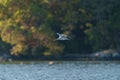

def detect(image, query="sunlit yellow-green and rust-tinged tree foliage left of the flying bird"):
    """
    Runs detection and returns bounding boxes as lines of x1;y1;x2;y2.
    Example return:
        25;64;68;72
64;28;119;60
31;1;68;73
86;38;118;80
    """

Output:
0;0;63;55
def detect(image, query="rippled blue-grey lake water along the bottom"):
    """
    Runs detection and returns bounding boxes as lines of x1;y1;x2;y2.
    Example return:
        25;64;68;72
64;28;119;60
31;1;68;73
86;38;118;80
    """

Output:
0;61;120;80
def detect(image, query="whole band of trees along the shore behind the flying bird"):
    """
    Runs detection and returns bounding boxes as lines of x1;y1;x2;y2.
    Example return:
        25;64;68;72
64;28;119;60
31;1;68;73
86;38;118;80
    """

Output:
0;0;120;59
